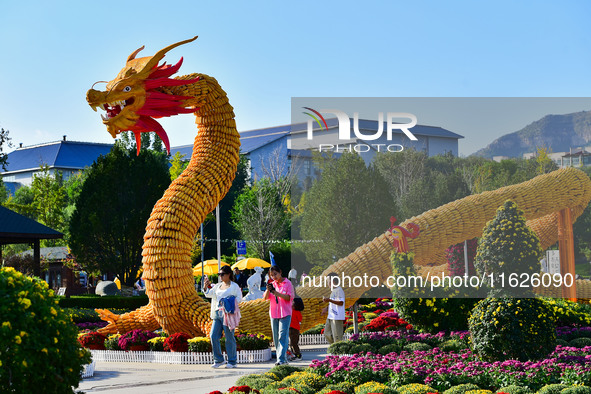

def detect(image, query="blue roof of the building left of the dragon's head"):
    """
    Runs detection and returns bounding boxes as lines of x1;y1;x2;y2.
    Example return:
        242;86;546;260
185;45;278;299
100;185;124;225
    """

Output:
4;141;113;174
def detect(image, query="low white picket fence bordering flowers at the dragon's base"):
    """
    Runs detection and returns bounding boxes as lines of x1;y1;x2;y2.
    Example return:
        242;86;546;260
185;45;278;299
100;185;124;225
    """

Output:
90;349;271;364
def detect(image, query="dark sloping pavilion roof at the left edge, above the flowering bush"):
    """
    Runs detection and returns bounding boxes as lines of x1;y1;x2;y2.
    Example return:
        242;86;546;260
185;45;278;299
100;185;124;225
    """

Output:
0;206;64;244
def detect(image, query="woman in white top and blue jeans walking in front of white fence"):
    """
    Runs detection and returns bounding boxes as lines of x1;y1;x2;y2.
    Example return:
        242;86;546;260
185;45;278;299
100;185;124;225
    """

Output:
203;265;242;368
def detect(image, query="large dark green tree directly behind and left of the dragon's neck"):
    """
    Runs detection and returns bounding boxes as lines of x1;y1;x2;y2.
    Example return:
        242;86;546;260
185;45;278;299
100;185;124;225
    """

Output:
69;144;170;286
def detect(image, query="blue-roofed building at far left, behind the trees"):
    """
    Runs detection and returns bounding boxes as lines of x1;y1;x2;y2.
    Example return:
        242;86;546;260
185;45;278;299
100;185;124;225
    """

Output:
0;136;113;190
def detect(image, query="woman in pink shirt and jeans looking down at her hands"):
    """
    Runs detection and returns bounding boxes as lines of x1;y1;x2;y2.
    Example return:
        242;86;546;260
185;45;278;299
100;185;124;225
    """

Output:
263;265;293;365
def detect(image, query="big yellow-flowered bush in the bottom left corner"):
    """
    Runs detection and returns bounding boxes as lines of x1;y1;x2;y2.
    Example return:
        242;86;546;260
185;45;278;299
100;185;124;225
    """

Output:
0;267;90;393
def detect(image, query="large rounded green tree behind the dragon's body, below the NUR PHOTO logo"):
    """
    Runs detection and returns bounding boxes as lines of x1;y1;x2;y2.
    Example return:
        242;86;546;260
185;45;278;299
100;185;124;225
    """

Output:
301;153;396;268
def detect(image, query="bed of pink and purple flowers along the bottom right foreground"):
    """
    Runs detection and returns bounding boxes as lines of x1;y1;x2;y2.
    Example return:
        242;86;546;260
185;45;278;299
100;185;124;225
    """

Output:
310;346;591;392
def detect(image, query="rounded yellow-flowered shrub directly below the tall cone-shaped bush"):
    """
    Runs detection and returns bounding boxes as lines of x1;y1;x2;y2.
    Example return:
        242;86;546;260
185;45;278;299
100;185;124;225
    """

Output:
468;298;556;361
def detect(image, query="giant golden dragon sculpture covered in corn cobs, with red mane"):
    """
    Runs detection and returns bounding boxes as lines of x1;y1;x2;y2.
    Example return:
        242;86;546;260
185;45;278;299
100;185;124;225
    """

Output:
87;37;591;336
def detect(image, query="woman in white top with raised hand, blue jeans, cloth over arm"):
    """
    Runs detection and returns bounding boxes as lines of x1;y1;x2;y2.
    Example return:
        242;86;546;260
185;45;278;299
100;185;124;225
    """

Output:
203;265;242;368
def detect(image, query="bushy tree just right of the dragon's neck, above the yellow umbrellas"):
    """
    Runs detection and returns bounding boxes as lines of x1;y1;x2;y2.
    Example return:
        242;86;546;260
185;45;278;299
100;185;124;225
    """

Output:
231;178;290;259
